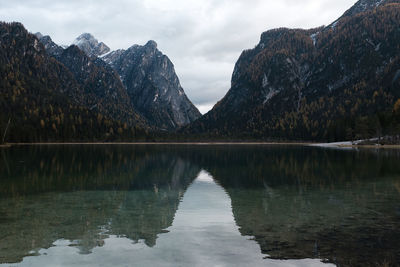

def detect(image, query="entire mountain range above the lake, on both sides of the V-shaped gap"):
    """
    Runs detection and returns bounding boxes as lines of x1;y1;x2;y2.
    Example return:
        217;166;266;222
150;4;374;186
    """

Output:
0;0;400;143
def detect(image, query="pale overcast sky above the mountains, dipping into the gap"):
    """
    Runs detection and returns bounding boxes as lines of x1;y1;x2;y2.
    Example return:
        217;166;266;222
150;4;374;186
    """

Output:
0;0;356;113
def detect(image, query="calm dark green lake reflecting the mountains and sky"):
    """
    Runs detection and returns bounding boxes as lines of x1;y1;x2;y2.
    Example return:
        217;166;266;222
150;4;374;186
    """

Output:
0;145;400;267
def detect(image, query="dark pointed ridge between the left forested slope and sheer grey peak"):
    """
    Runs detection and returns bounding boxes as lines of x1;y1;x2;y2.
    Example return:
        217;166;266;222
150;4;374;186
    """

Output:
35;33;144;125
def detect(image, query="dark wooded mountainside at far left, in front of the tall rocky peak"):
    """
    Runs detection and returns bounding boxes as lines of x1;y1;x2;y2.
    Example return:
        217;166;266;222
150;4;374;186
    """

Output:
0;23;148;142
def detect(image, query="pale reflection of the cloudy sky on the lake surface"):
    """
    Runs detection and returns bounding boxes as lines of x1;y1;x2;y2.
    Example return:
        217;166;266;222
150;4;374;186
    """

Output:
4;171;332;266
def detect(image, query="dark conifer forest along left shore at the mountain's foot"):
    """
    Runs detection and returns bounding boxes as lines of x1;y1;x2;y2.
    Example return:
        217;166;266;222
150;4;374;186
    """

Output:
0;79;150;142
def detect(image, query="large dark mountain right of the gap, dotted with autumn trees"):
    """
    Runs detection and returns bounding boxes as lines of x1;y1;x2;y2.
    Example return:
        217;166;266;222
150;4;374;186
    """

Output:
183;0;400;141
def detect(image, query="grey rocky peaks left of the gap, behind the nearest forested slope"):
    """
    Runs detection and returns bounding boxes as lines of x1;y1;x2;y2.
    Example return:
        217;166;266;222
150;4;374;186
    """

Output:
36;33;201;130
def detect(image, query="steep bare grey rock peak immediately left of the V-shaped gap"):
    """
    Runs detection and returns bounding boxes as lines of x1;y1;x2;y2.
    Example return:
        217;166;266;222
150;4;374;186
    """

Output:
101;41;201;130
